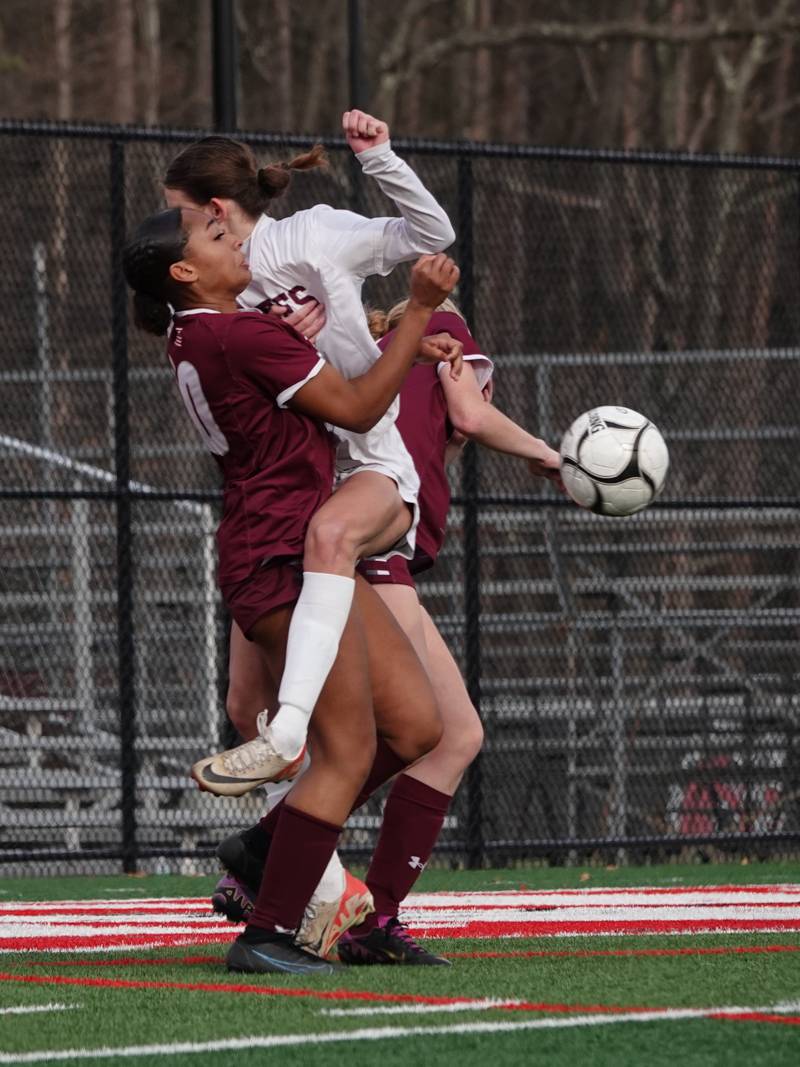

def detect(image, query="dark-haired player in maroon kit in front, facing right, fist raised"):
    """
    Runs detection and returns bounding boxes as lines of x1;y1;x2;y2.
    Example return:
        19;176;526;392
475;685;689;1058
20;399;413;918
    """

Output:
124;201;459;974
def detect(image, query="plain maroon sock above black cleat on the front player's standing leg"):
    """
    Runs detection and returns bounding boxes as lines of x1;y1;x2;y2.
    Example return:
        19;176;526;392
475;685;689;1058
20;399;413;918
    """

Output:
247;803;341;930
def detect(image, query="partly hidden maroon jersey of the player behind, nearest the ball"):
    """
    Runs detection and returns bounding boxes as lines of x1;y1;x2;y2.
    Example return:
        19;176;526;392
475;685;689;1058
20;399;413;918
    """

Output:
378;312;492;573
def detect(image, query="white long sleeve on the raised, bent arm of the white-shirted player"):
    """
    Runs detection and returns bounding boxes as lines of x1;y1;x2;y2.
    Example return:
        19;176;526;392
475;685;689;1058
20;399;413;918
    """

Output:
316;141;455;277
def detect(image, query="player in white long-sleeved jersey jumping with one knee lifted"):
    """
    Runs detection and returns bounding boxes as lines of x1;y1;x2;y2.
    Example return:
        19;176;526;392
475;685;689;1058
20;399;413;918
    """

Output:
164;111;454;795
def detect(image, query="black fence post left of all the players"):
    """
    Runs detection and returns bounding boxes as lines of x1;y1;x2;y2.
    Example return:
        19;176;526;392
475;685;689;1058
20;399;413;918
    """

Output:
109;141;137;873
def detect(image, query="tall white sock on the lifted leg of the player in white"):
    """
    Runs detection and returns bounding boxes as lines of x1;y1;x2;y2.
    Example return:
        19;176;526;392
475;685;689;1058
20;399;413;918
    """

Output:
270;571;355;759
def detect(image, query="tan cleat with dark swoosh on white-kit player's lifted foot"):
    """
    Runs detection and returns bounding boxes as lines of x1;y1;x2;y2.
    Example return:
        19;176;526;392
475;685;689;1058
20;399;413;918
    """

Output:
192;712;305;797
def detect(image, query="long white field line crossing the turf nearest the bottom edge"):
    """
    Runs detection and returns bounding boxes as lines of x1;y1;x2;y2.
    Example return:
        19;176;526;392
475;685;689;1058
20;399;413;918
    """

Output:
0;1002;800;1064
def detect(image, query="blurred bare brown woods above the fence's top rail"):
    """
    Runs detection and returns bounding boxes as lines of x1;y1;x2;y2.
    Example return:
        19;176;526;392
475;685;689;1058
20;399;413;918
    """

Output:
0;0;800;155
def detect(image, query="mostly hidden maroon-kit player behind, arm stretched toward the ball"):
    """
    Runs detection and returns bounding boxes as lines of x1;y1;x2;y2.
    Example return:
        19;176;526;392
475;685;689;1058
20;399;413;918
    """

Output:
214;301;562;965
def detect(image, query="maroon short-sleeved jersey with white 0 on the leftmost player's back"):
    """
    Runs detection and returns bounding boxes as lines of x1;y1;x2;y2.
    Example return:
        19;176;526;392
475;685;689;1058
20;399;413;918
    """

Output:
167;310;334;584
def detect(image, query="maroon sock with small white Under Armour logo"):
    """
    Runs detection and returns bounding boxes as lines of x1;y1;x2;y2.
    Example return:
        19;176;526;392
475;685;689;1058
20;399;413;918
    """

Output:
359;775;451;931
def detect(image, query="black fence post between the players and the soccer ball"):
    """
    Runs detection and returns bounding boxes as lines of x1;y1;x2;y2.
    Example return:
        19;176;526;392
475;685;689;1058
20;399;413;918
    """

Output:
458;156;483;867
